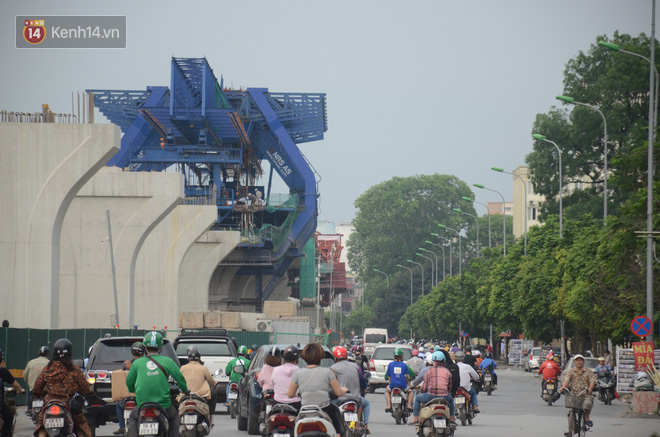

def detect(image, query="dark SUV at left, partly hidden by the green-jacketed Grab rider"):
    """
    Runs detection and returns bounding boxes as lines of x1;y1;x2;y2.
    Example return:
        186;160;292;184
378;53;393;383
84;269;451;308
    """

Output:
76;334;179;437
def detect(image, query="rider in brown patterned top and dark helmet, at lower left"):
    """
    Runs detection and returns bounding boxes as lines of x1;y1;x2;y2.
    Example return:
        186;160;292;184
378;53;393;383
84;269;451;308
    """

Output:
33;338;92;437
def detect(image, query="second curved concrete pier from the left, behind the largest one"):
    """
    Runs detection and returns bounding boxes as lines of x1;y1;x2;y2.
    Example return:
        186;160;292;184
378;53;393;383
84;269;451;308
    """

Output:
60;167;184;328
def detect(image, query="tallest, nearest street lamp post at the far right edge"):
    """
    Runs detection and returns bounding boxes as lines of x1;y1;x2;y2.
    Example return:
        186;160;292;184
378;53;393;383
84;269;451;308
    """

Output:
598;37;660;341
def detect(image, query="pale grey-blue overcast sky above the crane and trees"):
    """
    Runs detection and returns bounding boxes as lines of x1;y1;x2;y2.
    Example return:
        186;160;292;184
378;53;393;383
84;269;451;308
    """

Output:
0;0;657;223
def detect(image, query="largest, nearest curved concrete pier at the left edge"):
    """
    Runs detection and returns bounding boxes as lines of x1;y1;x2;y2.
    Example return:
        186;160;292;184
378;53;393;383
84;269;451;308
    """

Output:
0;123;120;328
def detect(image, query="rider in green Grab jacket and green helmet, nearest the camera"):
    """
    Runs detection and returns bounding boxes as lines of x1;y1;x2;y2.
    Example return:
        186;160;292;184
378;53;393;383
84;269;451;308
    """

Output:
126;331;188;437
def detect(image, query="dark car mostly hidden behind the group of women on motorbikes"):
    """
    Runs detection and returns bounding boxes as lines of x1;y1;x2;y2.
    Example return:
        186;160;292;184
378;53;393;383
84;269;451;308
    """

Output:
236;344;335;435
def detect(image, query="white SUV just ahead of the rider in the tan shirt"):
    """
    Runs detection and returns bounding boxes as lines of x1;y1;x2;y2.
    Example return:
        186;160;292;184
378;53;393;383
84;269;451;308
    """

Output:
174;328;238;403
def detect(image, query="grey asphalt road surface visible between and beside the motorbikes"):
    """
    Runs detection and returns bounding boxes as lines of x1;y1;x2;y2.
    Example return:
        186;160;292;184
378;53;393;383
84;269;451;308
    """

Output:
10;369;660;437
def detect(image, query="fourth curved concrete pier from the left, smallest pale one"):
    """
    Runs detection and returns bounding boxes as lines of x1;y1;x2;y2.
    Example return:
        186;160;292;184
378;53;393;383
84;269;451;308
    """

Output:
178;231;241;311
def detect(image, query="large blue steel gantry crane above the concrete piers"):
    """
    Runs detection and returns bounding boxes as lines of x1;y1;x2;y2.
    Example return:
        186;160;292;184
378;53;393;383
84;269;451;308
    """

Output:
87;58;327;310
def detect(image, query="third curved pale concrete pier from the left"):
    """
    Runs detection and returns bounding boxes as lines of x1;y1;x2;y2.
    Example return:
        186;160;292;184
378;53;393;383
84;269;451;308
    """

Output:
135;205;218;329
